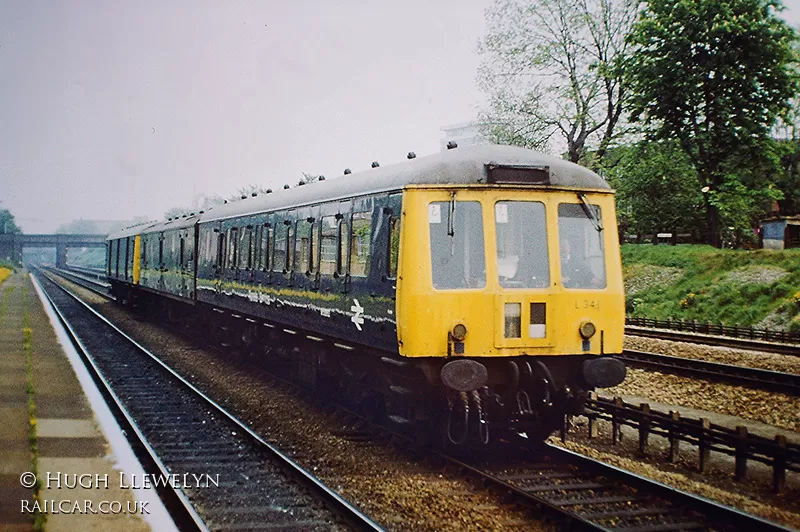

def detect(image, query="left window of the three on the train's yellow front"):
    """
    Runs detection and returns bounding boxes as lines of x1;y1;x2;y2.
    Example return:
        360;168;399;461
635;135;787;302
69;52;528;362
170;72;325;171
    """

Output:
428;201;486;290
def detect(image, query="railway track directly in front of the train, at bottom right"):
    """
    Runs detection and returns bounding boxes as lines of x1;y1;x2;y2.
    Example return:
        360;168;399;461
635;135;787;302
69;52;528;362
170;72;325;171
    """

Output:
42;268;788;531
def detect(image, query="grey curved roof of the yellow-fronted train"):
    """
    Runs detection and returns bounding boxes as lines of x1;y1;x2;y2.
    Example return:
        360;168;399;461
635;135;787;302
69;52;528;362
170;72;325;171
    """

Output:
108;144;611;239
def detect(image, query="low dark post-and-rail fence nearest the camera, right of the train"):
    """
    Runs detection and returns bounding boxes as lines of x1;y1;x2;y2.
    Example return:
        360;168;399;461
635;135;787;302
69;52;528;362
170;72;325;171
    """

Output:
561;393;800;493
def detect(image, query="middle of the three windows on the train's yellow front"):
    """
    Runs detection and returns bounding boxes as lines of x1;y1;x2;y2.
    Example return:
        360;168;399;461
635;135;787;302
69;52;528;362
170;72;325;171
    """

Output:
494;201;550;288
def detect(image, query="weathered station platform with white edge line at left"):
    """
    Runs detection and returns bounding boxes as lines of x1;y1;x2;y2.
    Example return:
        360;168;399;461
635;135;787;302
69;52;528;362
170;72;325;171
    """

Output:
0;270;174;532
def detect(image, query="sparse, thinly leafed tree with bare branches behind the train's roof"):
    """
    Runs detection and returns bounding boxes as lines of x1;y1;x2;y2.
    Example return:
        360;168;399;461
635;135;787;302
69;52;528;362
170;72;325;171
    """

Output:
478;0;638;167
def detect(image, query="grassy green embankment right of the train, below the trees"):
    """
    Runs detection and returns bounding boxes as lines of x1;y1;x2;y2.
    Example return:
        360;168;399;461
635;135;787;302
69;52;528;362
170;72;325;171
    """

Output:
622;244;800;332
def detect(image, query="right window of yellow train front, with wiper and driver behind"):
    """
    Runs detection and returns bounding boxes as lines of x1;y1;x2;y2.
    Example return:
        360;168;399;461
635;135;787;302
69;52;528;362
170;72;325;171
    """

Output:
558;203;606;289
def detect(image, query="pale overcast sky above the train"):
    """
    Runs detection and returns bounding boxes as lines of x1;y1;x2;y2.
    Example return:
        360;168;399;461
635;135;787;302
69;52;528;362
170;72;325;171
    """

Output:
0;0;800;233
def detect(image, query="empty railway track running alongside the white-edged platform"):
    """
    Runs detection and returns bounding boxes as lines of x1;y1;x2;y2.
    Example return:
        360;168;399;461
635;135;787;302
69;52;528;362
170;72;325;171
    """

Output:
37;275;380;530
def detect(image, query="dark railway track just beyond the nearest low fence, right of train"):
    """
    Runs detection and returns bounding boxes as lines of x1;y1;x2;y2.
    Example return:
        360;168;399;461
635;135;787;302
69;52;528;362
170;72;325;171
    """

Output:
618;350;800;397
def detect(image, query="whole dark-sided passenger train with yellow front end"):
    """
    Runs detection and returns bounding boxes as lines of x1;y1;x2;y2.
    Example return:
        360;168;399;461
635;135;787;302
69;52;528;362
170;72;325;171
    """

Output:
108;146;625;444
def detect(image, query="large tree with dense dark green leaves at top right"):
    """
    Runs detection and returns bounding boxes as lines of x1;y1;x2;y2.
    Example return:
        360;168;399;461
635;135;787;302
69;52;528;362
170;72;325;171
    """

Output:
626;0;798;247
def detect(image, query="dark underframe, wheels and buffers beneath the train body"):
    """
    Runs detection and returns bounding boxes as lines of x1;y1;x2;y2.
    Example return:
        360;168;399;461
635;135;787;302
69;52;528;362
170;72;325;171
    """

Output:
115;283;625;447
